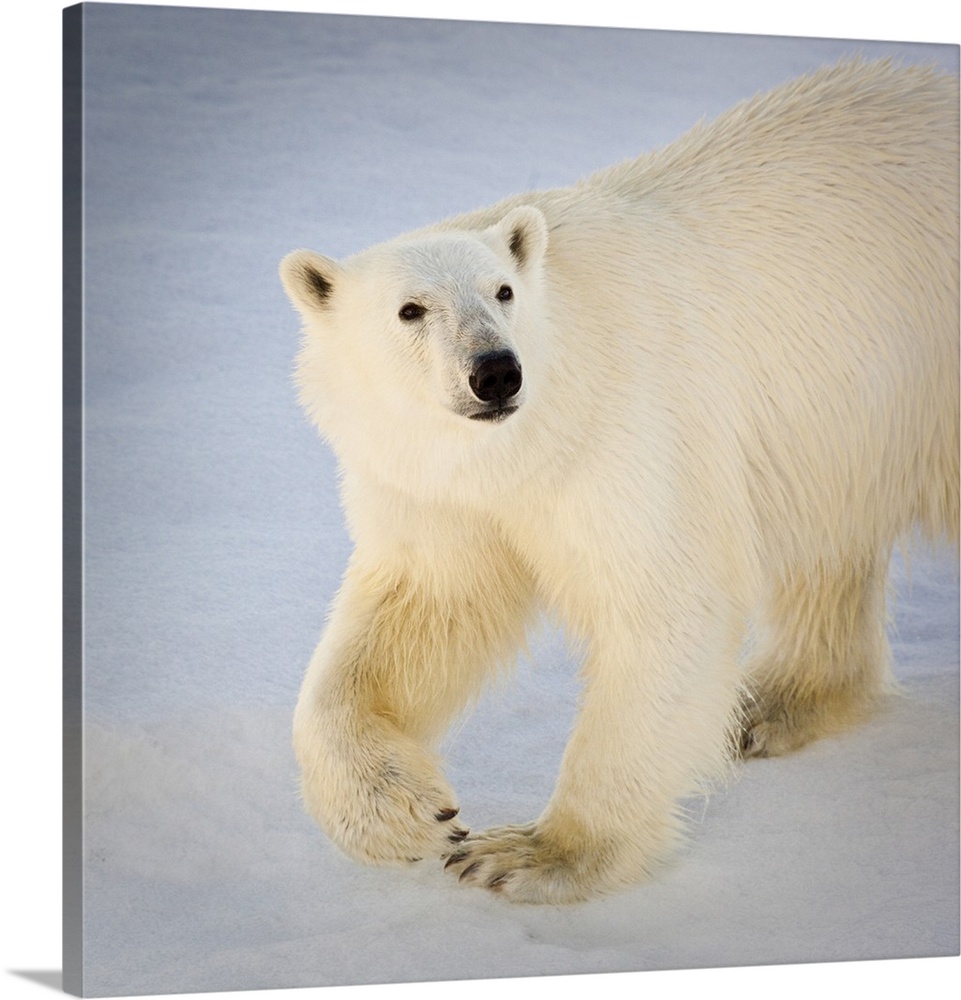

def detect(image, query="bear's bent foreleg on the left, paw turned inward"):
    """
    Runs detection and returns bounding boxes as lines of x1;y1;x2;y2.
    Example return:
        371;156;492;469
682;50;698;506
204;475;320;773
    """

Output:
294;541;531;864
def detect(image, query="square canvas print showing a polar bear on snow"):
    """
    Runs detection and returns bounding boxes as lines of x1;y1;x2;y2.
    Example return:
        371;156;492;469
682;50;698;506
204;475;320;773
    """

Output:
64;3;959;996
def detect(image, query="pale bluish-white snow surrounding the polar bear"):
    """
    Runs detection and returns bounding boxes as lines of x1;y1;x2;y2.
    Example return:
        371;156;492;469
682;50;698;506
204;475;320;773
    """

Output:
69;4;959;996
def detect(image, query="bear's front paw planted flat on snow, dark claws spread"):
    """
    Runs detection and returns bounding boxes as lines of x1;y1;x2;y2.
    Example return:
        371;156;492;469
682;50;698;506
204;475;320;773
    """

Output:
445;823;613;903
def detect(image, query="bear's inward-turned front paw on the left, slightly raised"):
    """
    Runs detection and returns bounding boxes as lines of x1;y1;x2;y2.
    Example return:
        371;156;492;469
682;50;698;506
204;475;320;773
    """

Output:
299;720;467;865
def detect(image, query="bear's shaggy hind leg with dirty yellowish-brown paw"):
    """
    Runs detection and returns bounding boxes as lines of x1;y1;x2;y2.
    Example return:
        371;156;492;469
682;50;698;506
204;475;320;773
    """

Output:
740;558;891;757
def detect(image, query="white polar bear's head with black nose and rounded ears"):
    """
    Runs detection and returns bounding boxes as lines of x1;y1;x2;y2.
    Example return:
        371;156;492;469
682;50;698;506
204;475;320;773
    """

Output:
280;205;548;478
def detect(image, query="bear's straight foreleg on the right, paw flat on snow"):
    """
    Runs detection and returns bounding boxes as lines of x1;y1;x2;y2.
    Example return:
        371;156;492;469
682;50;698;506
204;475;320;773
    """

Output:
447;592;738;903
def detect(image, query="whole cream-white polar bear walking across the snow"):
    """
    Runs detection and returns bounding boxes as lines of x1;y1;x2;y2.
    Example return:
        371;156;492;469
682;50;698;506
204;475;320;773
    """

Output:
281;61;959;903
